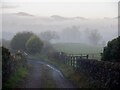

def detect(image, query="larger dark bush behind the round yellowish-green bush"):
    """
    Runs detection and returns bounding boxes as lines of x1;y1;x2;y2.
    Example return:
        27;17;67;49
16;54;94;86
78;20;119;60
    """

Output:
11;32;34;50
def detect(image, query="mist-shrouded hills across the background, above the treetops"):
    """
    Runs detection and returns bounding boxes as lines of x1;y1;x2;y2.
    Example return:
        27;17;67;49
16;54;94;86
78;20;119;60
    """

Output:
3;12;117;41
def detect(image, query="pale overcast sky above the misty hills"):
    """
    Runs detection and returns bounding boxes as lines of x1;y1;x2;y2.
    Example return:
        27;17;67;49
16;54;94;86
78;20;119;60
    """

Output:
2;0;119;18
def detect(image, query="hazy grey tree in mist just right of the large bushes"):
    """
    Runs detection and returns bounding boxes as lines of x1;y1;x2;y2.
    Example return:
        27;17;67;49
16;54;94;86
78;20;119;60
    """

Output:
40;30;59;42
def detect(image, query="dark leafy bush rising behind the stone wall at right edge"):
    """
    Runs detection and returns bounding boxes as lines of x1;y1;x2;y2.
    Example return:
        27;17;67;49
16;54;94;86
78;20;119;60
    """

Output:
102;36;120;62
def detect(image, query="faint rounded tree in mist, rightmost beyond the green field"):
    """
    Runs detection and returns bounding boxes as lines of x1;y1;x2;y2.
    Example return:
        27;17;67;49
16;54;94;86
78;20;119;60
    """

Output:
88;29;102;45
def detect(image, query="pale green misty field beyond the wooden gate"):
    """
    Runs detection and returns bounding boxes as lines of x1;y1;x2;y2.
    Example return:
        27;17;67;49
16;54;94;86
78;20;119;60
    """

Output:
53;43;102;60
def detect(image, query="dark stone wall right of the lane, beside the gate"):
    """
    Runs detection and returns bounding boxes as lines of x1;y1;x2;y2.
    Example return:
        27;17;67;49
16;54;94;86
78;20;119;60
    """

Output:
76;59;120;88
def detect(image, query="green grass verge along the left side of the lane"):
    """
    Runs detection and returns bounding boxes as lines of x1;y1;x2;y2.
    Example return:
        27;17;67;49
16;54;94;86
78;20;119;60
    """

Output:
4;67;27;88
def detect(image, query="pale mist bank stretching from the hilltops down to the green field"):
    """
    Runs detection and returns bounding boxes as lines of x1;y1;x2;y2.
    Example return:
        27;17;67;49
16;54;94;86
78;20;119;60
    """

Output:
0;12;118;44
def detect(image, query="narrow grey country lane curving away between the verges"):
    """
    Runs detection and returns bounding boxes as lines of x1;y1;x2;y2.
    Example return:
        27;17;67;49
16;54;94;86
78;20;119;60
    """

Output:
19;60;75;88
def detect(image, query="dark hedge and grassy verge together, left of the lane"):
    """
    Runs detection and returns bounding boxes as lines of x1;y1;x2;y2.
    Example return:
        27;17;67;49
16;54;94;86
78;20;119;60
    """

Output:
1;47;27;88
